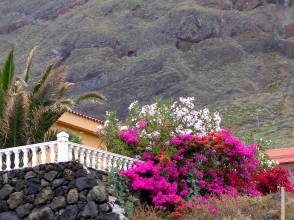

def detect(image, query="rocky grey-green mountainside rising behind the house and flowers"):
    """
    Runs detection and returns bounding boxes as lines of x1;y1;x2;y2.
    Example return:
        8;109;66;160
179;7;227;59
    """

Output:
0;0;294;147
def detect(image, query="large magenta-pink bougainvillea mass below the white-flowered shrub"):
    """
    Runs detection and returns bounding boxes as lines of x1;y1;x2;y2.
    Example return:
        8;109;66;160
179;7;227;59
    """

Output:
121;130;260;211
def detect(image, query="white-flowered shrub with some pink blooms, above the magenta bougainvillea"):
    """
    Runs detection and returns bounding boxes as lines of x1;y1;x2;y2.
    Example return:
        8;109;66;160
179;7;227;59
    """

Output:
98;97;221;156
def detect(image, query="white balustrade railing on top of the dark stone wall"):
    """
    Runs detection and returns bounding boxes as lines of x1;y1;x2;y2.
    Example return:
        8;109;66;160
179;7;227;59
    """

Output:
0;132;140;171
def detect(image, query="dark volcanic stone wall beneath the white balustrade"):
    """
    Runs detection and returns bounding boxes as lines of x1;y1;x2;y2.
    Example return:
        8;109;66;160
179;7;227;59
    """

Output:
0;162;119;220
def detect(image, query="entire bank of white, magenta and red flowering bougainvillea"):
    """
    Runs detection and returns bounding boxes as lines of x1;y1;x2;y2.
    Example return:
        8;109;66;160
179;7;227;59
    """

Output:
103;98;293;217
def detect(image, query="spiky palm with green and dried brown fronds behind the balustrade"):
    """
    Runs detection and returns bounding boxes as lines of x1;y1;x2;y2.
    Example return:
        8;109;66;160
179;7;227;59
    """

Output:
0;48;105;148
